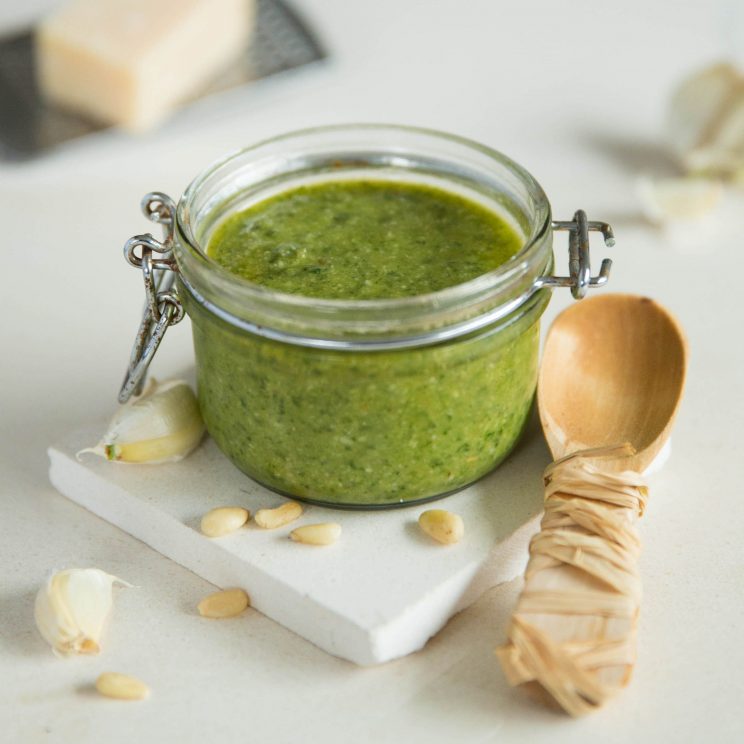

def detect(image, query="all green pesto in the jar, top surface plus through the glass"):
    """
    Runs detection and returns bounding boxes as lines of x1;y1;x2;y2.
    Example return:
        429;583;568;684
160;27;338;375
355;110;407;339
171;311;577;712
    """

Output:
190;181;547;507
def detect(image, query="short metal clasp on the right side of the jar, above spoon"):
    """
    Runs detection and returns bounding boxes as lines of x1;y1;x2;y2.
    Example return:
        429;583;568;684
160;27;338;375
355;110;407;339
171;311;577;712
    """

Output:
535;209;615;300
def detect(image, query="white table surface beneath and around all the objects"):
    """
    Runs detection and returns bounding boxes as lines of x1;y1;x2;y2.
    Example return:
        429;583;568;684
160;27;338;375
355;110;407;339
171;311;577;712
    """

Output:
0;0;744;744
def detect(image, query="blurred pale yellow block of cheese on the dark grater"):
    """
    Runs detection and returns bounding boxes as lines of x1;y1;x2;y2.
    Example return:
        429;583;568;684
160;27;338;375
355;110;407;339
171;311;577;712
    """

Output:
36;0;255;130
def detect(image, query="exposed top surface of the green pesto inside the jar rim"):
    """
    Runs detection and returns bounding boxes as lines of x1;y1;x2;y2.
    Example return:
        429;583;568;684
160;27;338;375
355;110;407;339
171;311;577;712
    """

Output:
207;181;521;300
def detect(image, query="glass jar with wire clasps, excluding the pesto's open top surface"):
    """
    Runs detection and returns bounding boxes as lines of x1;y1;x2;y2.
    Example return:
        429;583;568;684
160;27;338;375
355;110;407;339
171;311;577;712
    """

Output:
120;125;611;509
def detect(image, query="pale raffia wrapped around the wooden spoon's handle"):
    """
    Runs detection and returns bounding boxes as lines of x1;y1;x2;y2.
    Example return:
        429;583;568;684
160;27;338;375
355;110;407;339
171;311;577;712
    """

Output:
496;445;648;716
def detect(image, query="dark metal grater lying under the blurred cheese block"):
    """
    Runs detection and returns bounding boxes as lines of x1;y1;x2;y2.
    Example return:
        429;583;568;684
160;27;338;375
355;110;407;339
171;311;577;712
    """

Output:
0;0;326;160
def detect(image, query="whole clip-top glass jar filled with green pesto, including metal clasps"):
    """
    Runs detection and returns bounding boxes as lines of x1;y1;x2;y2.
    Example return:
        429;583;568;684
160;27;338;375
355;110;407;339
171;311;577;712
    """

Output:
120;125;611;508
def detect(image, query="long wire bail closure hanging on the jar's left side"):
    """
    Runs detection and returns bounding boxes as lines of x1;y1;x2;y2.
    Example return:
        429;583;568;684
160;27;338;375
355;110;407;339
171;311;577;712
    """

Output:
119;191;184;403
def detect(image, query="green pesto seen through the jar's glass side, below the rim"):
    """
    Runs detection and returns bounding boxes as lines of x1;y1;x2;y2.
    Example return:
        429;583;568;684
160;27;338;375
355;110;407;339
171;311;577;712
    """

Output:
183;293;547;507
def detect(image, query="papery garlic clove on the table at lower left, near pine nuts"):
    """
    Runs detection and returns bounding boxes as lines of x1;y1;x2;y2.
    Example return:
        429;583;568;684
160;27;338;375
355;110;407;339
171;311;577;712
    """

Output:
34;568;131;656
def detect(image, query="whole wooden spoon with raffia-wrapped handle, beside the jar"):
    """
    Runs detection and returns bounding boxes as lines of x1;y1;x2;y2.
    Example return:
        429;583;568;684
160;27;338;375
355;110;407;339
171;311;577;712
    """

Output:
497;294;687;715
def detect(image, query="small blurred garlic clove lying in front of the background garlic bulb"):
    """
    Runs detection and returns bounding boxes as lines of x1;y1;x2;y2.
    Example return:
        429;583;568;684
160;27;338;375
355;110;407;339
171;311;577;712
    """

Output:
638;178;723;224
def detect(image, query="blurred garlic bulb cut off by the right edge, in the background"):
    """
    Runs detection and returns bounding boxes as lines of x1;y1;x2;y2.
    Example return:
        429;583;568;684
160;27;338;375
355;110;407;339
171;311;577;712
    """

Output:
667;63;744;176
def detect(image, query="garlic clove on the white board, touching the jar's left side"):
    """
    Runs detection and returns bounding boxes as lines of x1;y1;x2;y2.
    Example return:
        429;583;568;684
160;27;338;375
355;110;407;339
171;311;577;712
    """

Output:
78;380;204;465
